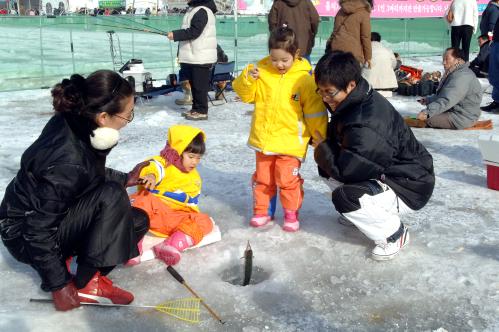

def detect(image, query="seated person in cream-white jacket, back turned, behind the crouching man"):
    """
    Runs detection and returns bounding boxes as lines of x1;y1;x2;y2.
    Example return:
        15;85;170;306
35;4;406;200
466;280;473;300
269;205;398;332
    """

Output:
363;32;397;97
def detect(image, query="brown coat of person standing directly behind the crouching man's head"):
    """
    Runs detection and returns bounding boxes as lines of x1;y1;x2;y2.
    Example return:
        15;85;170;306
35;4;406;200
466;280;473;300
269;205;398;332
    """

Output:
329;0;372;63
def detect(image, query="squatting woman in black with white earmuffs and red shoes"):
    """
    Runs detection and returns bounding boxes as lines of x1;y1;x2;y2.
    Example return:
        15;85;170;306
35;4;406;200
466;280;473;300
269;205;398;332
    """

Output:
0;70;149;311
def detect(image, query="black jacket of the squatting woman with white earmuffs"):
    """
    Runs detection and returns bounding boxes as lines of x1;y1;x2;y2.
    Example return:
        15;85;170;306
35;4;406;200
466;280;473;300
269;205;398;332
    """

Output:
0;114;126;291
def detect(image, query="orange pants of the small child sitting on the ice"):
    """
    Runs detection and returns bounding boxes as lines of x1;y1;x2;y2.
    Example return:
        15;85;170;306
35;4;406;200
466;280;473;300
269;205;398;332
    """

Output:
130;190;213;244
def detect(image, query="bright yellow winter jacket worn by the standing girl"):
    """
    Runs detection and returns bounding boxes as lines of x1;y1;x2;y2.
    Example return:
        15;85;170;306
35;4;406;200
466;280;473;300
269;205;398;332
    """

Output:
232;56;328;160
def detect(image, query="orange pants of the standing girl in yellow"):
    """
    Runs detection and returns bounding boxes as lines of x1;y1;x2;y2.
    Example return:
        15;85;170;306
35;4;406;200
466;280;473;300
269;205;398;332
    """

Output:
252;152;303;215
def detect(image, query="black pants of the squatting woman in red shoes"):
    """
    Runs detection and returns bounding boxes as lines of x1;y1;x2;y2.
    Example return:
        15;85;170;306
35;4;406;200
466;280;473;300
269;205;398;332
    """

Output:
58;181;149;288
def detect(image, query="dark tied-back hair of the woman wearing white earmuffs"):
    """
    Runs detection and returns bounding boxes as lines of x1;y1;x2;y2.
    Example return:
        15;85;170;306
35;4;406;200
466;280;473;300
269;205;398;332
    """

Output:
51;70;134;120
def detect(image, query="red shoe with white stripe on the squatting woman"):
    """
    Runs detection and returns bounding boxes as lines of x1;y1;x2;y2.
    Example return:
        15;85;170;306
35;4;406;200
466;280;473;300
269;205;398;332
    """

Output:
78;272;133;304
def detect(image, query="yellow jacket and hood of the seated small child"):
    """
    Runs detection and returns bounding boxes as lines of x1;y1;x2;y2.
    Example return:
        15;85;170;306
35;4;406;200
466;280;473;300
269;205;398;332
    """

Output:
139;125;206;212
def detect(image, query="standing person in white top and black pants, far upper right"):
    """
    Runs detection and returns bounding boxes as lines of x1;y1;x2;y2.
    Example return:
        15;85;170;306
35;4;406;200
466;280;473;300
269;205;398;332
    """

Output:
446;0;478;61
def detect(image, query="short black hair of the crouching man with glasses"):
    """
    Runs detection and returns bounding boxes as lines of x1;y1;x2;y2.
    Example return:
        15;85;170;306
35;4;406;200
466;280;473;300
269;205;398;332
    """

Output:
314;51;362;90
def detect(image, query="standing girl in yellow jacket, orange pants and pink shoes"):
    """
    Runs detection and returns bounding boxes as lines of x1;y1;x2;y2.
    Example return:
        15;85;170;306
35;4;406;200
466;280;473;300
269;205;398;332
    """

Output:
233;26;327;232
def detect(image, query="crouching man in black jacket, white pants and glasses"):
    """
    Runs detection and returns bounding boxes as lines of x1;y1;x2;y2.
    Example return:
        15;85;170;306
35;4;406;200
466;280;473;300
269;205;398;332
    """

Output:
312;52;435;260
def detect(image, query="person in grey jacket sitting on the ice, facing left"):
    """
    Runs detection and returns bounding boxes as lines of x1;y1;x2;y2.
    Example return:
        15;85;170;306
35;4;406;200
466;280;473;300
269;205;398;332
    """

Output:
417;47;482;129
